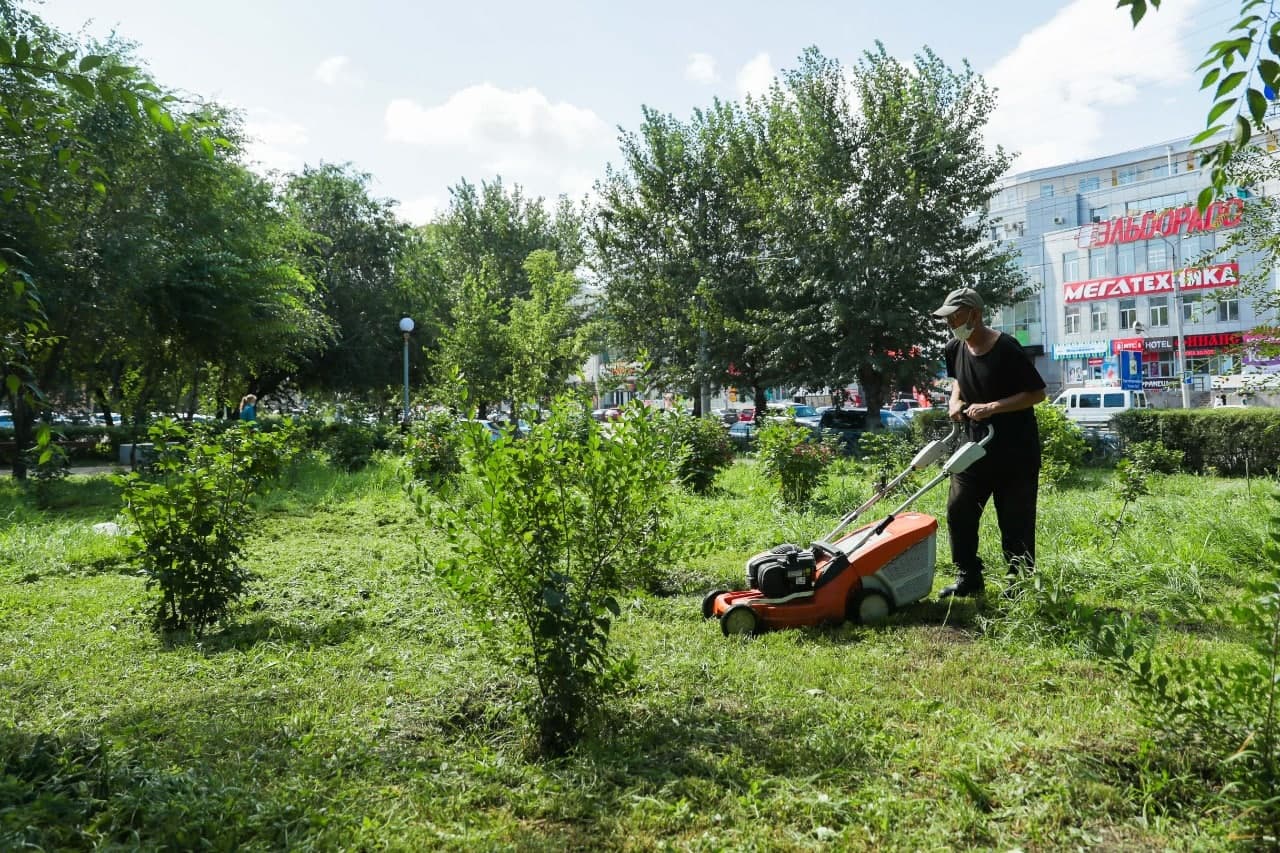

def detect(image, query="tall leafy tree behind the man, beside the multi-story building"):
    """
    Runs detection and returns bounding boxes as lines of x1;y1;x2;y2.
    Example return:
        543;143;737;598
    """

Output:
755;45;1023;410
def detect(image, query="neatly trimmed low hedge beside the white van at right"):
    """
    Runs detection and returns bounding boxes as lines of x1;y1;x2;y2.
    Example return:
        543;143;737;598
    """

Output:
1111;409;1280;475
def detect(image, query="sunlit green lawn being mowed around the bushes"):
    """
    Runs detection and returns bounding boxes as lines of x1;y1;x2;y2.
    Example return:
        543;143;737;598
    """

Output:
0;461;1272;850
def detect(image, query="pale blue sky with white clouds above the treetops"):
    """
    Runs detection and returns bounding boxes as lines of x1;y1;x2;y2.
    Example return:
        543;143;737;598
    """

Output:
35;0;1223;223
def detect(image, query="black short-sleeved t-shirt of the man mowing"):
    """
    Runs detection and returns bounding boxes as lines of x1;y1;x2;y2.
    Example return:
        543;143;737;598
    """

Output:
946;332;1044;467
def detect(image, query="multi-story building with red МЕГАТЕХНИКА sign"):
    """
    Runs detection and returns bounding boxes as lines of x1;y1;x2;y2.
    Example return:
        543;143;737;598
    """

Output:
988;138;1271;400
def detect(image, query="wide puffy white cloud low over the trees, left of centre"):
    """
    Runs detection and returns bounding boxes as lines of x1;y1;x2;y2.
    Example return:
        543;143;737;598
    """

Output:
385;83;616;199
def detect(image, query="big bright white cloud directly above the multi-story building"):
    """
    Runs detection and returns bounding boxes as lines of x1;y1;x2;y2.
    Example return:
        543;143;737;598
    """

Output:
986;0;1199;170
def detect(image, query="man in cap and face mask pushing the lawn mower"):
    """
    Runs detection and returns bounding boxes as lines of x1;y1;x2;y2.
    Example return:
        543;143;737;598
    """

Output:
933;287;1044;598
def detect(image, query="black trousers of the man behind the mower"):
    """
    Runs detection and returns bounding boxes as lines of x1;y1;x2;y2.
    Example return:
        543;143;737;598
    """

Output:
947;459;1039;576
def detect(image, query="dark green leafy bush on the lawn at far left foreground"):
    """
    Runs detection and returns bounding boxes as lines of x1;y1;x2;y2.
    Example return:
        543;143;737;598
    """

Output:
116;420;293;637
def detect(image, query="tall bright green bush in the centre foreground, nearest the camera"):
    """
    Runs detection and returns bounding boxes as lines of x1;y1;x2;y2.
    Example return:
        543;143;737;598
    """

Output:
417;400;678;754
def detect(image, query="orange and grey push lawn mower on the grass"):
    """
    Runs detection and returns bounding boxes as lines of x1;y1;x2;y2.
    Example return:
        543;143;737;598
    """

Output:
703;424;995;637
